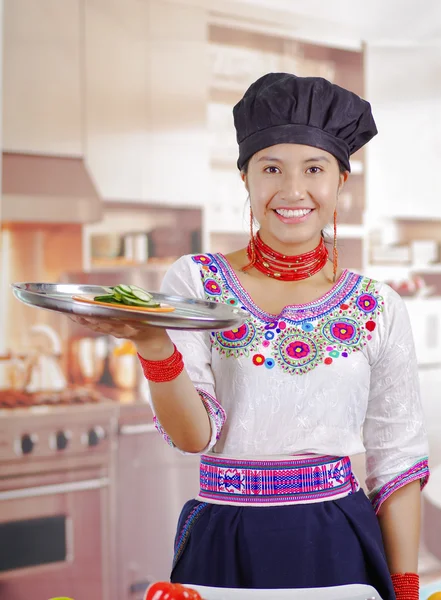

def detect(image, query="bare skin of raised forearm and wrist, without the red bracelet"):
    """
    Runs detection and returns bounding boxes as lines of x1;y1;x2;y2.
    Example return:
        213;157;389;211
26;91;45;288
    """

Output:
134;329;211;453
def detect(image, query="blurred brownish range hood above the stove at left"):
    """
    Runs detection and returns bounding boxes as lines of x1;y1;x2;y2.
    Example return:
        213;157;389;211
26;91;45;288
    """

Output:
0;152;102;224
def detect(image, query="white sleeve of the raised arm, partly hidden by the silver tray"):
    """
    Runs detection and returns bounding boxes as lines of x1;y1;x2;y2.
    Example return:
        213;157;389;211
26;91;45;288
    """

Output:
144;256;226;454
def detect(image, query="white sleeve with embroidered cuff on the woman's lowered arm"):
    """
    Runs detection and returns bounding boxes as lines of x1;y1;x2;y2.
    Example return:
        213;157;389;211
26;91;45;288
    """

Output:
363;286;429;512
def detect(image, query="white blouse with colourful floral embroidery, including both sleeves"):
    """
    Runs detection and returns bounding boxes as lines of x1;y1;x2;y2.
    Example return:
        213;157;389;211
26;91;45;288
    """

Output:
150;254;429;510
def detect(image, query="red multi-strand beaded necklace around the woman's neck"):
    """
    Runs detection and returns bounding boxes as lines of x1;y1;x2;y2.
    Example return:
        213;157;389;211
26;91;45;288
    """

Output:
243;232;328;281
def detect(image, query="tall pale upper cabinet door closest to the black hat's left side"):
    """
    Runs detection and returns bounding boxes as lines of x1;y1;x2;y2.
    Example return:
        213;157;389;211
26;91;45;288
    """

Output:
142;0;210;206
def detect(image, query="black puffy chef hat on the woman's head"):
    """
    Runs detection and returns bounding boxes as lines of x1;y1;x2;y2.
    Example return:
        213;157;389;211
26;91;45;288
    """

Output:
233;73;377;171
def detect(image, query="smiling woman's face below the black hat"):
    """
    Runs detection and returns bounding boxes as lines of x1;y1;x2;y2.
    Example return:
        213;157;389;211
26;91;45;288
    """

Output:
242;144;348;254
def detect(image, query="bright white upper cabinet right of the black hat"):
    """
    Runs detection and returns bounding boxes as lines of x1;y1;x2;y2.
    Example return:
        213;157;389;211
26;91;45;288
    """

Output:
366;42;441;220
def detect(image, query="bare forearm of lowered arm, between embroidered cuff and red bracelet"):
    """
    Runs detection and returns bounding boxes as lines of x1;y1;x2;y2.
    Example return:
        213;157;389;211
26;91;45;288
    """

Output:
378;481;421;574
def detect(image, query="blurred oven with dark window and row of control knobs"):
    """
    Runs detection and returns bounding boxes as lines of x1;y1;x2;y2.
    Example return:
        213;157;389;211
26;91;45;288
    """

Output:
0;404;117;600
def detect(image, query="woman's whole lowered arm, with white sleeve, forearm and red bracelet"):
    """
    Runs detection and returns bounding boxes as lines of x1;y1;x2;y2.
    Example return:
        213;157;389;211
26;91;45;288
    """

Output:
363;286;429;600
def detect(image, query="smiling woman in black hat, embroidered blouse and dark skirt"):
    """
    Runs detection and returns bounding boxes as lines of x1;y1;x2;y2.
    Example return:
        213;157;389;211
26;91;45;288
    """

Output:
77;73;428;600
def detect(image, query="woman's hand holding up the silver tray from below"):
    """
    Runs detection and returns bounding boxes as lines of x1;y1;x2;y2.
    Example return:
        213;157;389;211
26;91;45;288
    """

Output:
69;315;173;360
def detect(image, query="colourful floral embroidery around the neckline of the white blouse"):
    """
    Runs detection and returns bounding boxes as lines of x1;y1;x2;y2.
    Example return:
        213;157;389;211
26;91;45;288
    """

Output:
192;254;384;375
